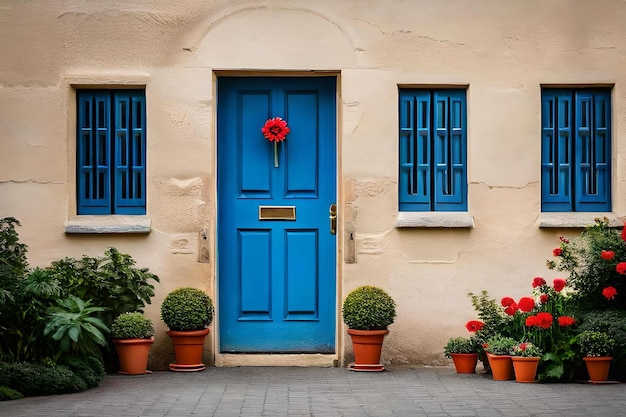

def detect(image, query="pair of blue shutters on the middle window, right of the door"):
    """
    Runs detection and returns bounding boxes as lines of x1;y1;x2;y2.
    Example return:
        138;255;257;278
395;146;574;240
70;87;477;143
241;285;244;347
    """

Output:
398;89;467;211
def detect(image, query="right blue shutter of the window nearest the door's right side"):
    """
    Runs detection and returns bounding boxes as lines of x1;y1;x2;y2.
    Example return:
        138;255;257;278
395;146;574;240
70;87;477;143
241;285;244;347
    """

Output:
433;90;467;211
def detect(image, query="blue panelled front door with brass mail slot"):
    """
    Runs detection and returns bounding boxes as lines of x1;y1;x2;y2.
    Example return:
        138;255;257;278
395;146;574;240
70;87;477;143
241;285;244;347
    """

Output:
217;77;337;353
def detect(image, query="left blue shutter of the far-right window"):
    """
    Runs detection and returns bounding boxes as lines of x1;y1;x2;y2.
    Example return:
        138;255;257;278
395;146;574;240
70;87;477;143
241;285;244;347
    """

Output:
541;89;574;212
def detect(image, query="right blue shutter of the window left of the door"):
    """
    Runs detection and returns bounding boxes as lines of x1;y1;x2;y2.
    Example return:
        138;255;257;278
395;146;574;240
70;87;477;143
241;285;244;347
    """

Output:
113;91;146;214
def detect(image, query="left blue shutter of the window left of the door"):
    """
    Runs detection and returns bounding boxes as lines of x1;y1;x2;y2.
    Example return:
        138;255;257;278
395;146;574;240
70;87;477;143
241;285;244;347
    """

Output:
76;91;111;214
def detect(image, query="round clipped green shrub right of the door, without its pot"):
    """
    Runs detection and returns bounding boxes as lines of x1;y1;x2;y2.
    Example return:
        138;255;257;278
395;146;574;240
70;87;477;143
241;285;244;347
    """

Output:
342;285;396;330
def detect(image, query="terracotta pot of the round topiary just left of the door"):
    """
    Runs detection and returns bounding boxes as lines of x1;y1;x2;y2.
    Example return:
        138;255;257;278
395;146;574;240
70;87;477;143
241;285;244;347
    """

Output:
167;328;209;372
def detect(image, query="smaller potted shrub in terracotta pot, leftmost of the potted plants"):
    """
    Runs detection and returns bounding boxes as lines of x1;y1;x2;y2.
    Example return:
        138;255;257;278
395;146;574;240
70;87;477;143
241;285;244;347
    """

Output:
111;312;154;375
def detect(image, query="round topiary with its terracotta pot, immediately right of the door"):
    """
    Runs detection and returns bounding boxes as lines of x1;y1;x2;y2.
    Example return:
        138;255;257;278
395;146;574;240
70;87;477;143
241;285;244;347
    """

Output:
342;285;396;371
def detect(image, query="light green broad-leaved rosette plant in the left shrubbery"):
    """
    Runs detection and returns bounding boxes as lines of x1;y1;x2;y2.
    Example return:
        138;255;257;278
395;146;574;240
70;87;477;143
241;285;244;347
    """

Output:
44;295;109;357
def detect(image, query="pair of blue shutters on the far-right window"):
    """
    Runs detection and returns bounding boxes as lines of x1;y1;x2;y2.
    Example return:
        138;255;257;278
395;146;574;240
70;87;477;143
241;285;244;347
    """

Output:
541;88;611;212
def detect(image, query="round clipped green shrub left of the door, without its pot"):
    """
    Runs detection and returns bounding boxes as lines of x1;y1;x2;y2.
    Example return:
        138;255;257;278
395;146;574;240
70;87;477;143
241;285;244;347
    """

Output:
161;287;213;331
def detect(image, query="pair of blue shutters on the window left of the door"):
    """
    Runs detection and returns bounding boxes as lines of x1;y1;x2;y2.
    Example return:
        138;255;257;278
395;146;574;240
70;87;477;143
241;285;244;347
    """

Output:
76;90;146;214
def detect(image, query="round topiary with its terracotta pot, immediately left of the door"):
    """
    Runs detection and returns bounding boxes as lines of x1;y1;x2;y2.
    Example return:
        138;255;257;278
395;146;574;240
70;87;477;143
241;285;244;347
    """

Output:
161;287;213;371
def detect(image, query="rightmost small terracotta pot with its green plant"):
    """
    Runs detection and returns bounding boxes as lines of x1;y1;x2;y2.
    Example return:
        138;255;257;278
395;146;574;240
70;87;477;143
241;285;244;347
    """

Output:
578;330;615;382
